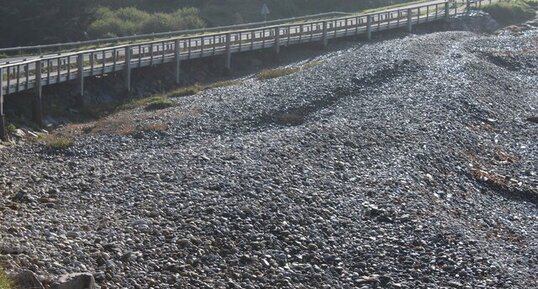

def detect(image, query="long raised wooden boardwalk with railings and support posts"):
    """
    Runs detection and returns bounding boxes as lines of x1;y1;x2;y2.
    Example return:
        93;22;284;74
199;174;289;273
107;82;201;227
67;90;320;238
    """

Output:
0;0;486;139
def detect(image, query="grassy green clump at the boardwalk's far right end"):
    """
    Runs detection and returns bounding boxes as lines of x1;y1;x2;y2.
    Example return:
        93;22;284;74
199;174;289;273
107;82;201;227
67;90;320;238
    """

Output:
483;0;536;25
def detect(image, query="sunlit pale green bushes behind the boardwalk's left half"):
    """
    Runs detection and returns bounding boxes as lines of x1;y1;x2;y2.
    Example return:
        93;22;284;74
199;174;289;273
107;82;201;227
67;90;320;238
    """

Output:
88;7;205;38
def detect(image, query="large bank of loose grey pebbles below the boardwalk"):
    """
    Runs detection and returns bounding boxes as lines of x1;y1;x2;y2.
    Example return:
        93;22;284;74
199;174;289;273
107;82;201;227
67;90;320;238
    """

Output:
0;25;538;288
